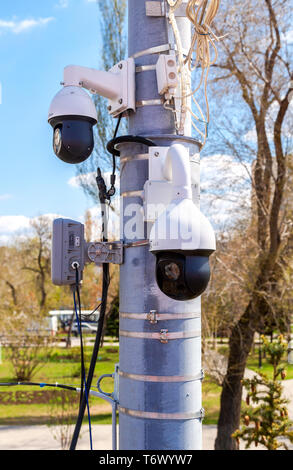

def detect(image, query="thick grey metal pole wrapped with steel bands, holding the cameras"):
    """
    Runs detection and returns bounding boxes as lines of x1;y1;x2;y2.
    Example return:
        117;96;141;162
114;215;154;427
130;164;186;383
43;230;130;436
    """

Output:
119;0;202;450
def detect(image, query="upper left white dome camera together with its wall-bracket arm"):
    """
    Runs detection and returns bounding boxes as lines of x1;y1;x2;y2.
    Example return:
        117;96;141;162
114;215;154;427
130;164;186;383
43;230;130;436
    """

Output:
48;58;135;164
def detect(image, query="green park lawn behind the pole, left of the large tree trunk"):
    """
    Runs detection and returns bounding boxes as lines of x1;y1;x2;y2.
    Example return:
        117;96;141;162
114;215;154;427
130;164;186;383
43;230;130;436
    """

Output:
0;345;221;425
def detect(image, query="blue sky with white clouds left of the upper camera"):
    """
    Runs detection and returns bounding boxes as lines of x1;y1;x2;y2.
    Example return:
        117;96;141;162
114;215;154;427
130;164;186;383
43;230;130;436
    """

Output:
0;0;101;241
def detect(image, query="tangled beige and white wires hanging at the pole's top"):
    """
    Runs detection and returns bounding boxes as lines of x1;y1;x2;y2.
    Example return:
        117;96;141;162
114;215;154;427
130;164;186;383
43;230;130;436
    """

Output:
167;0;222;146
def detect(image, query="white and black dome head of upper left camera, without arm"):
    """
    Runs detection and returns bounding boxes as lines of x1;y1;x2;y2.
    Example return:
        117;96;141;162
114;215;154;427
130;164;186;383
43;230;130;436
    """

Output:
48;86;97;163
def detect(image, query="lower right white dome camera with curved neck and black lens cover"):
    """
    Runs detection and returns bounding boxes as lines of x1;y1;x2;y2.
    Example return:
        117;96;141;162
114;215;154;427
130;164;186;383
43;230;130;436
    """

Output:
150;145;216;300
